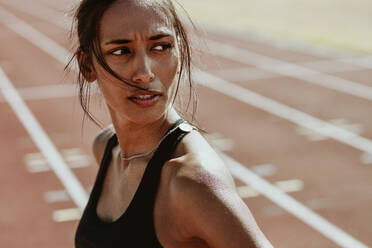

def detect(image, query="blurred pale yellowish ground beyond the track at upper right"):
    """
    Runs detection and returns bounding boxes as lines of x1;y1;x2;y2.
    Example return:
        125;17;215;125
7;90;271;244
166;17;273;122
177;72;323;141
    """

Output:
179;0;372;54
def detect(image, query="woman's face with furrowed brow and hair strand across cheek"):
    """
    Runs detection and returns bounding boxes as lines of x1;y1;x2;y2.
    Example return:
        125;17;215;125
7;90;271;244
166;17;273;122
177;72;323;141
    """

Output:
89;0;179;123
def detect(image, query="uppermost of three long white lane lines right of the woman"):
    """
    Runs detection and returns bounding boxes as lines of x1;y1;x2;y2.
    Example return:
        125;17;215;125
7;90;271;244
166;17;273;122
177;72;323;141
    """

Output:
207;40;372;101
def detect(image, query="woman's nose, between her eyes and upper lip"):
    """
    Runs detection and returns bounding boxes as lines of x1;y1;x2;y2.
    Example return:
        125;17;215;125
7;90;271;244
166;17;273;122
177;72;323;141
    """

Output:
132;51;155;83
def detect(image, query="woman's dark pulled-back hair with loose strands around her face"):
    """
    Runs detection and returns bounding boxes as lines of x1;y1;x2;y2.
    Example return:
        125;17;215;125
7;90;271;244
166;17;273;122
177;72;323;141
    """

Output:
65;0;198;127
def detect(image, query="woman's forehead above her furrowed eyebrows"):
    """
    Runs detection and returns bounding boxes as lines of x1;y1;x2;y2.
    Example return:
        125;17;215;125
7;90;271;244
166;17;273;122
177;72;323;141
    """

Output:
100;0;172;40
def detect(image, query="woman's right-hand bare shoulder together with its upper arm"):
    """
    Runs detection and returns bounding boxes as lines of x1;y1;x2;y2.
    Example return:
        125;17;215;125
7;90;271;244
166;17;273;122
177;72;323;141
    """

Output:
167;132;272;248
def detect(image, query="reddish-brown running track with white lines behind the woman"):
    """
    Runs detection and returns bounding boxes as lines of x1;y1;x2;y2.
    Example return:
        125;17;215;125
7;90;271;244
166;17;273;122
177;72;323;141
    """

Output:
0;0;372;248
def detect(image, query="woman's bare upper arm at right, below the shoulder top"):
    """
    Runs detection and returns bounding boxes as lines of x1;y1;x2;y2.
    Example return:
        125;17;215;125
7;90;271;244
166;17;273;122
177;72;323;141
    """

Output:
173;165;272;248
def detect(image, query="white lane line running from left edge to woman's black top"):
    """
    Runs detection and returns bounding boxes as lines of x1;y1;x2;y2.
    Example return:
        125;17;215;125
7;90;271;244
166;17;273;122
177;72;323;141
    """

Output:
0;68;88;210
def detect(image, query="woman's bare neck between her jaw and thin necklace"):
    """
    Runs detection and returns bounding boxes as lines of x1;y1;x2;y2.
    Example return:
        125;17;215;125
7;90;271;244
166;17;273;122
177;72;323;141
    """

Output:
111;108;180;162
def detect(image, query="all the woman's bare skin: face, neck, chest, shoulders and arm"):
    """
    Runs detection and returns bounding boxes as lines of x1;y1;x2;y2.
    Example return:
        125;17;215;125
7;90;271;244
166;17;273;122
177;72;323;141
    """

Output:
78;0;272;248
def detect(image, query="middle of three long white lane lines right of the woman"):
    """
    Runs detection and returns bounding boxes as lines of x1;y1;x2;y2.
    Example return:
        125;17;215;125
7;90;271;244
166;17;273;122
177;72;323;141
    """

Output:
194;71;372;153
